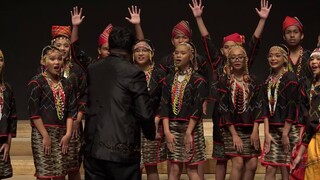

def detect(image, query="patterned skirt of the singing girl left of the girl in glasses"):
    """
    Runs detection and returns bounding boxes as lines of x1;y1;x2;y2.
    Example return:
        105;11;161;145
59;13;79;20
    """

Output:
168;120;206;165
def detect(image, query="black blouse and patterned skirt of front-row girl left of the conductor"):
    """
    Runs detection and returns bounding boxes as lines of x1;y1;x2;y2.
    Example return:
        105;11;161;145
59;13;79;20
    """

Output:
28;74;77;178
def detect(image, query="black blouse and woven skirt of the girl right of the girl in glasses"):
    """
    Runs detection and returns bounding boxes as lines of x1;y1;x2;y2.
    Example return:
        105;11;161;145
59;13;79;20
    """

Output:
261;72;299;167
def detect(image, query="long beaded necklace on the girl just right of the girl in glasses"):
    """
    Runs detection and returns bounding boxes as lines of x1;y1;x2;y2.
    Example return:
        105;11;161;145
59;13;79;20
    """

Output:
268;71;286;116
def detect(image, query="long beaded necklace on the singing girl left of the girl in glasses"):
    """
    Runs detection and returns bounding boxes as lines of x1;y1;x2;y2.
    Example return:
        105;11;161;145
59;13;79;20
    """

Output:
171;68;192;115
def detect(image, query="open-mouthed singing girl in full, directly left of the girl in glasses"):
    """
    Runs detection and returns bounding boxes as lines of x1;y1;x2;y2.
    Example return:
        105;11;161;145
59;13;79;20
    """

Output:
160;43;208;179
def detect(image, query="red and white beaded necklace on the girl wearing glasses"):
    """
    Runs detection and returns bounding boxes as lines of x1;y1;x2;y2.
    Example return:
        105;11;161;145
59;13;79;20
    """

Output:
230;74;249;114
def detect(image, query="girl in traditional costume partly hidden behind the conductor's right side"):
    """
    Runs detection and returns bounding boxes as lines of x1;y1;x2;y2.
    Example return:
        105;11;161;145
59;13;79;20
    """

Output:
133;39;167;180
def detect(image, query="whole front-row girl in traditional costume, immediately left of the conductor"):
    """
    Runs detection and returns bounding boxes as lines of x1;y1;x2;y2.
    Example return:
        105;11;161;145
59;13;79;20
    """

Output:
28;45;76;179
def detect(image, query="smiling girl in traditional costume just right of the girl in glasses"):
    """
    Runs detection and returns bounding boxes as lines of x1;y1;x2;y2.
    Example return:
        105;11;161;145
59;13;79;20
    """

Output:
261;44;299;180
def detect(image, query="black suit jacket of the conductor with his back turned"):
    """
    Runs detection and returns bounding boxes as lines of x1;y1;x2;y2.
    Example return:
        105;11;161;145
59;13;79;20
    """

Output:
84;55;155;163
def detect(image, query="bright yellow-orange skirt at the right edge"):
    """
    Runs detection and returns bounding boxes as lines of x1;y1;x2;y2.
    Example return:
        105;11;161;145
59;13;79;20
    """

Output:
304;130;320;180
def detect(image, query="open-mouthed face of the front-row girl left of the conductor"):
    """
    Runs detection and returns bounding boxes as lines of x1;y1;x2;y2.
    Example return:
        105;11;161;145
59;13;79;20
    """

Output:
41;49;64;78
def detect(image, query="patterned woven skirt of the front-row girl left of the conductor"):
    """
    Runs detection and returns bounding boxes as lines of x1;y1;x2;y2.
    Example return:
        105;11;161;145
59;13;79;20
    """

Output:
31;127;68;178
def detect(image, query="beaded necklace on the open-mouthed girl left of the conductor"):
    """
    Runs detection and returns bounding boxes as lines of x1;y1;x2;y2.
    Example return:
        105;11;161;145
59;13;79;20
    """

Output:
43;73;66;120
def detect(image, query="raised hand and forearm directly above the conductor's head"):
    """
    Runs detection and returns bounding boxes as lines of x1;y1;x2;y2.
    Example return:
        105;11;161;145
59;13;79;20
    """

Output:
125;6;144;40
